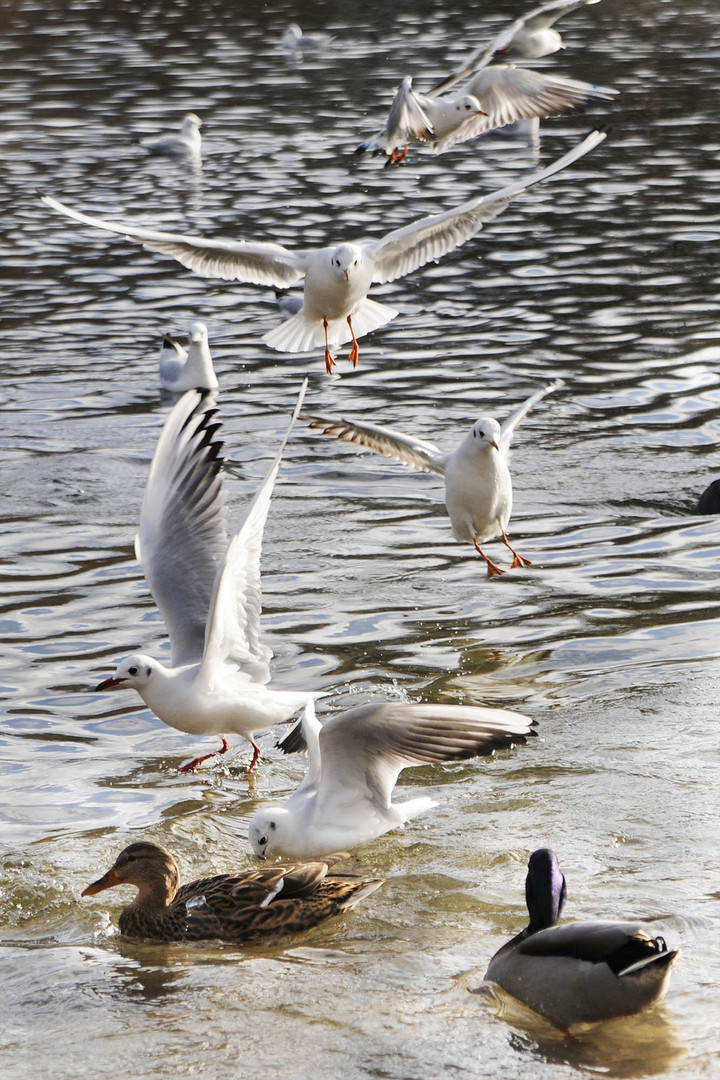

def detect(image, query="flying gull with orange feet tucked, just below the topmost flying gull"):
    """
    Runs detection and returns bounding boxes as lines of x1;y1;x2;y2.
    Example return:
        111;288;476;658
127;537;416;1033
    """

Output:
357;64;619;165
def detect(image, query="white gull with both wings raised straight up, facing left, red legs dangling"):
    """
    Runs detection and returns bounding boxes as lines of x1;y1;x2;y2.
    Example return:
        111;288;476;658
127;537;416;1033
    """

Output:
95;380;321;774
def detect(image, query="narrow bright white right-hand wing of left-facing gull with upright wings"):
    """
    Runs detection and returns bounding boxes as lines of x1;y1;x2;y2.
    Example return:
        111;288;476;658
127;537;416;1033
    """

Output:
203;379;308;684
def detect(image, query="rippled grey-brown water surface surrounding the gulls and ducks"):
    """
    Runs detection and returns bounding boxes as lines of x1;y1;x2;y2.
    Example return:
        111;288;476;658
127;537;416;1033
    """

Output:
0;0;720;1080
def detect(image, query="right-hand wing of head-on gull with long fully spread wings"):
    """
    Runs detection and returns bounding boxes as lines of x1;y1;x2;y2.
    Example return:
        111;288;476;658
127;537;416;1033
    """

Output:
363;131;606;282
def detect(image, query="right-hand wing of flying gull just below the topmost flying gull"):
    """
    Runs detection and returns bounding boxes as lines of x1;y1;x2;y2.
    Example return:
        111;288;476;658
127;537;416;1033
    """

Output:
433;64;619;153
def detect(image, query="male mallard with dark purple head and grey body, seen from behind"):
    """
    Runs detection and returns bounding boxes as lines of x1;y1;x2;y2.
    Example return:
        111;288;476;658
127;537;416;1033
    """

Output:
485;848;680;1029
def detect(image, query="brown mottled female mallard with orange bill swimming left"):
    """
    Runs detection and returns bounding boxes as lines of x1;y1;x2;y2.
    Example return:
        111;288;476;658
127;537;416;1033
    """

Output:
82;840;382;944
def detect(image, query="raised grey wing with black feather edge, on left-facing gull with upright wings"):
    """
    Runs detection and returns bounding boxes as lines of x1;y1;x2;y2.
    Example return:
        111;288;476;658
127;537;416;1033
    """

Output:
135;390;228;665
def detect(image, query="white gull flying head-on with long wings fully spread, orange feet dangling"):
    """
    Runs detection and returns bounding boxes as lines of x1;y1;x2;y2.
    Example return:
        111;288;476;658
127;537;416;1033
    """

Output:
42;131;606;374
